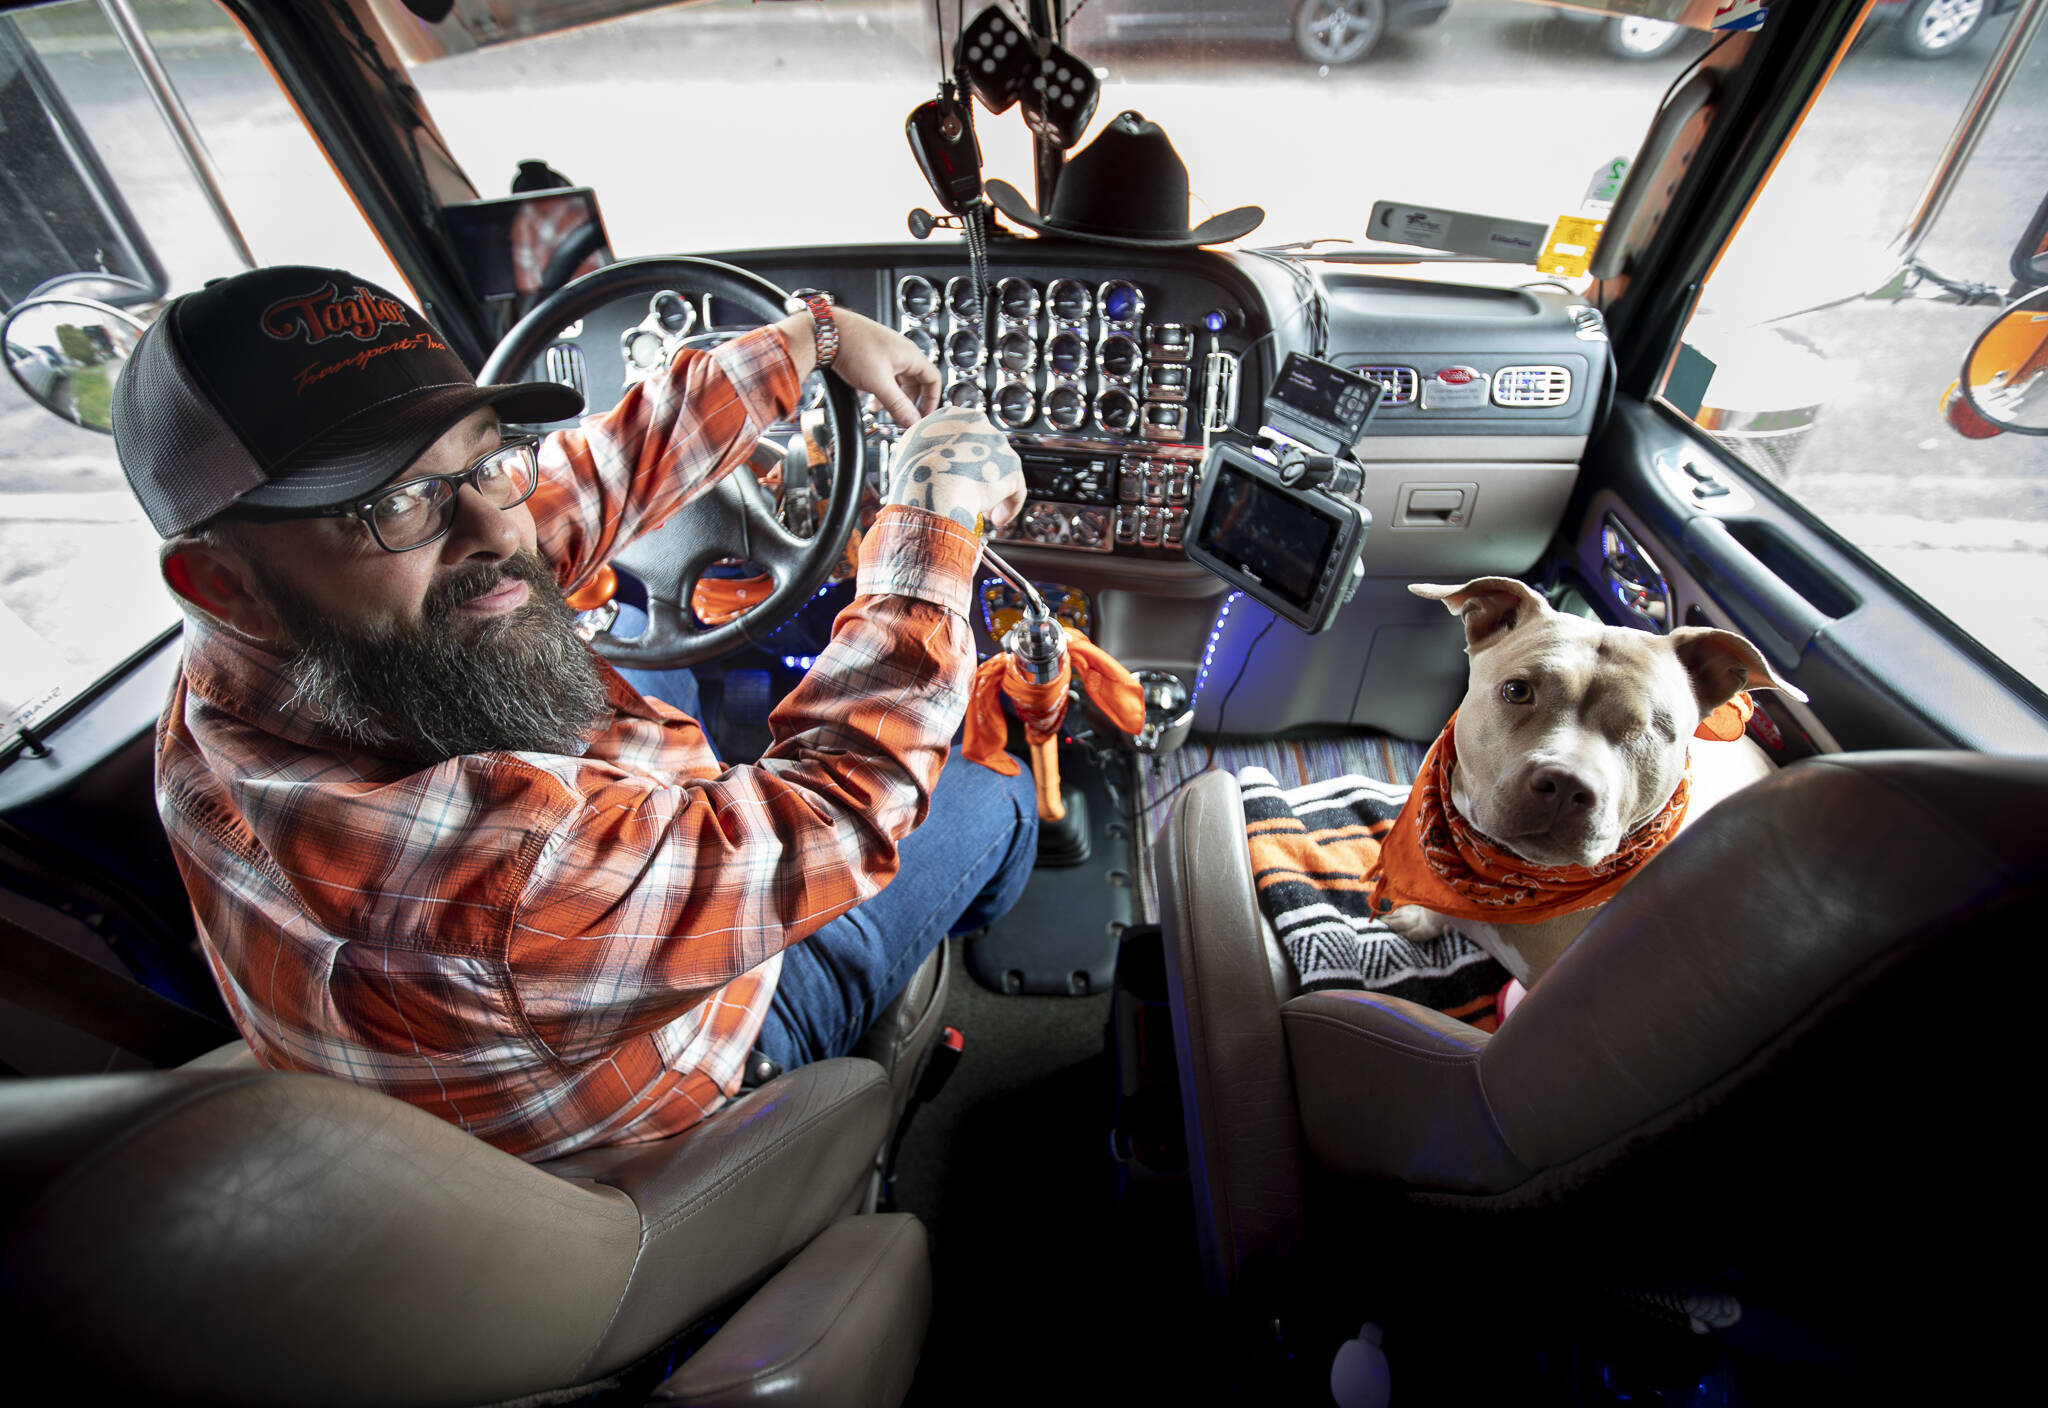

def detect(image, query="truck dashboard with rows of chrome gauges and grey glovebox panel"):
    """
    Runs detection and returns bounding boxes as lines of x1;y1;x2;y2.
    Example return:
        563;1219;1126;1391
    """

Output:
541;239;1612;737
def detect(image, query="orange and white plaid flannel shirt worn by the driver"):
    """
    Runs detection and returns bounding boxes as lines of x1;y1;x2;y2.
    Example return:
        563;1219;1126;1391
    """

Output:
158;329;977;1158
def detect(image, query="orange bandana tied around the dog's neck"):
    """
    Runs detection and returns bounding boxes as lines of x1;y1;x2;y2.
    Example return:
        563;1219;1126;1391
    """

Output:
1366;694;1755;923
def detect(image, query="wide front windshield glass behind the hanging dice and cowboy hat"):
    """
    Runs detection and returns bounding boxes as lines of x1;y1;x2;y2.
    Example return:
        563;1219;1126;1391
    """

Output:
393;0;1710;260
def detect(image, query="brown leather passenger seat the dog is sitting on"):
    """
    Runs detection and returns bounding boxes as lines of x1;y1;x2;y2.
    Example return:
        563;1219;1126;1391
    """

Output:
1157;753;2048;1381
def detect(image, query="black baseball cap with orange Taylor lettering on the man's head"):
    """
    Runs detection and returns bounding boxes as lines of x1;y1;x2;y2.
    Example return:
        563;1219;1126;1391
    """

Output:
113;266;584;538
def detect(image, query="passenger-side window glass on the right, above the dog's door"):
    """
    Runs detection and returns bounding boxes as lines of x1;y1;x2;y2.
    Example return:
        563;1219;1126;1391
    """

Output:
1667;11;2048;688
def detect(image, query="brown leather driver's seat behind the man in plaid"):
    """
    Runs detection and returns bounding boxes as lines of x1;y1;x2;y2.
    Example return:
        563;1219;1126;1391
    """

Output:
0;950;946;1406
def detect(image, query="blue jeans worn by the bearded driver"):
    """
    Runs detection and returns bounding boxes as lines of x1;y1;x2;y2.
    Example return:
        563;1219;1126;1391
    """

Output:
618;622;1038;1070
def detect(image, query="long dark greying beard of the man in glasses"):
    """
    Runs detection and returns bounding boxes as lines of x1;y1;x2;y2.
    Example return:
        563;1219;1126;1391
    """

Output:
256;551;610;763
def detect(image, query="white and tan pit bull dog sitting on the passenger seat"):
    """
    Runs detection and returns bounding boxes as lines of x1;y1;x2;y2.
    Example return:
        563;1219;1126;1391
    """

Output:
1384;577;1806;986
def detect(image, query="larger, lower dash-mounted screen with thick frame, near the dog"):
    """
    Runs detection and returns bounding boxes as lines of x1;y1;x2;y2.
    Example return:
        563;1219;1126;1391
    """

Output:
1184;442;1372;634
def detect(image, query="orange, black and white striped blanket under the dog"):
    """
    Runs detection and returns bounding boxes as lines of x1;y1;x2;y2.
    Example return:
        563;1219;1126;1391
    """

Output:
1237;767;1507;1031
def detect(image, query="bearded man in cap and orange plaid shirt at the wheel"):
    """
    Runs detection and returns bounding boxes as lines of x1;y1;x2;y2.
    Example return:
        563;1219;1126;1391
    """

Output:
115;268;1036;1160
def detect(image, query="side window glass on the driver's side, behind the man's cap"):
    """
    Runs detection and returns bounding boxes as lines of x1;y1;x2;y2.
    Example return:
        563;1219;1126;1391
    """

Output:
0;0;406;743
